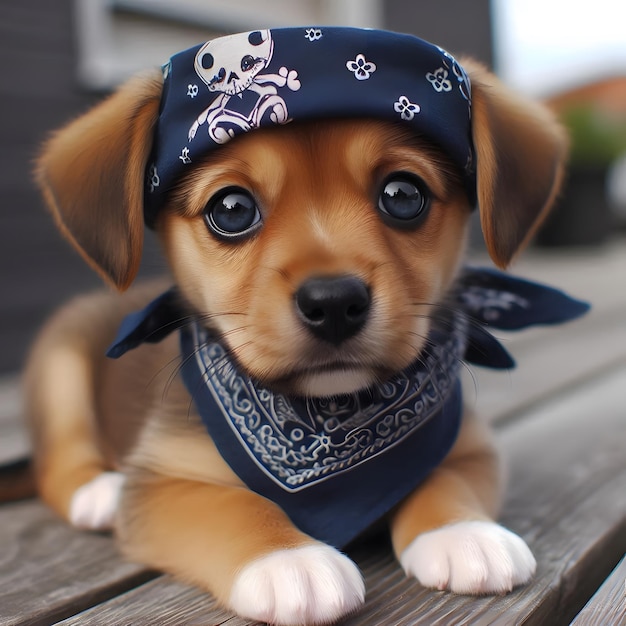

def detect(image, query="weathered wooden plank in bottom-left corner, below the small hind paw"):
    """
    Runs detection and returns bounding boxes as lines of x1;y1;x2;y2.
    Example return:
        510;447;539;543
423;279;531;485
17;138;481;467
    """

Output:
0;501;154;626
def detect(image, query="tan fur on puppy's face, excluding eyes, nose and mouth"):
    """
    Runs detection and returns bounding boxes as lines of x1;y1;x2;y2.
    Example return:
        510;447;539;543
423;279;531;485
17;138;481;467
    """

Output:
160;122;469;385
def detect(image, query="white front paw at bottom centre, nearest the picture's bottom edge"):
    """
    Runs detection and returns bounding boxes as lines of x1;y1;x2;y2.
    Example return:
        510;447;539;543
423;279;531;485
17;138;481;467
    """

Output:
230;544;365;625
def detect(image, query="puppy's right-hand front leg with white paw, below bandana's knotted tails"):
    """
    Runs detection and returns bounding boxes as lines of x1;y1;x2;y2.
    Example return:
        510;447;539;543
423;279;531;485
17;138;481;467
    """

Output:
391;415;536;594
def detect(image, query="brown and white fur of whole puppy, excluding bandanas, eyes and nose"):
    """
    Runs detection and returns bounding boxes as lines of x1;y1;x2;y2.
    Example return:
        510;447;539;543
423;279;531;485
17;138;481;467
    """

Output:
26;28;566;624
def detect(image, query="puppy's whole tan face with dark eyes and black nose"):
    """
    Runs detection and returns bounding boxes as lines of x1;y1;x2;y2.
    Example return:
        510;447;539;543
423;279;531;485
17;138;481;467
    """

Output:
157;121;469;395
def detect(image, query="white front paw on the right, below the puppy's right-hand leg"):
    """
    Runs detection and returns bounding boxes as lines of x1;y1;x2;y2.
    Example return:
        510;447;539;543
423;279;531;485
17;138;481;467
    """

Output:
400;521;537;594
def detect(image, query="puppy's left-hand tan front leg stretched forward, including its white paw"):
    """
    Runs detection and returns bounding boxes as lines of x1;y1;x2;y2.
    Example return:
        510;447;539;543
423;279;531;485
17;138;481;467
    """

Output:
118;473;364;624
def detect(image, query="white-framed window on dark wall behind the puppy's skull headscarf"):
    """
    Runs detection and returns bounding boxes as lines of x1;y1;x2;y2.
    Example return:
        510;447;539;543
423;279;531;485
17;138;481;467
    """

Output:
75;0;382;90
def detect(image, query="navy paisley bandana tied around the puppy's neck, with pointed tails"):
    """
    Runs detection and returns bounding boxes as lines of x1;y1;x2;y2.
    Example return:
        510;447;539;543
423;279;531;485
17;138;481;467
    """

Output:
108;268;589;548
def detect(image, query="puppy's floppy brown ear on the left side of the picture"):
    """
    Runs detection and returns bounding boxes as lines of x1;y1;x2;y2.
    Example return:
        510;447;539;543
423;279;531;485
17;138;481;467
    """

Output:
36;73;162;290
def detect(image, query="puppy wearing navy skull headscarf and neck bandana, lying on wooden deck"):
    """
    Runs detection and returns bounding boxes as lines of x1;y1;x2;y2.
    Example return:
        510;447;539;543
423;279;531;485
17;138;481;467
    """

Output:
26;28;566;624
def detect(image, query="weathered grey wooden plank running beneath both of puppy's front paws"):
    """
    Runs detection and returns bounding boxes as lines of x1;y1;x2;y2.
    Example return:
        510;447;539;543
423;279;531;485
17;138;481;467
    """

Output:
53;367;626;626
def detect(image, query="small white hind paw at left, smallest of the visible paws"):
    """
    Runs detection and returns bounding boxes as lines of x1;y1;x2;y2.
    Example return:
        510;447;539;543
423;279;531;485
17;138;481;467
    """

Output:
70;472;124;530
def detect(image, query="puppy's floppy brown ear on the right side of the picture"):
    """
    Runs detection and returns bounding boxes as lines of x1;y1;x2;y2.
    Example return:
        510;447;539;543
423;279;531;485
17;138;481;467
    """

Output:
463;60;568;267
